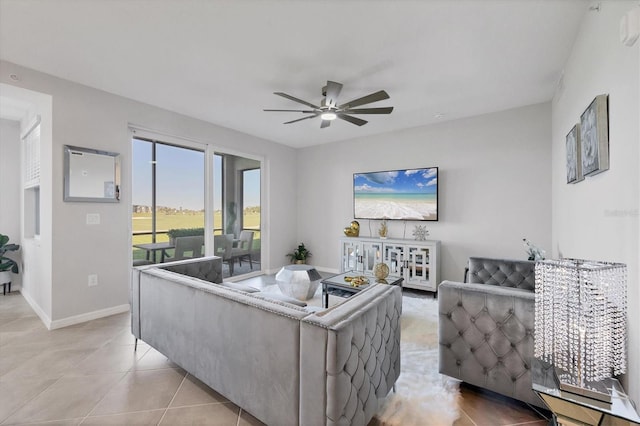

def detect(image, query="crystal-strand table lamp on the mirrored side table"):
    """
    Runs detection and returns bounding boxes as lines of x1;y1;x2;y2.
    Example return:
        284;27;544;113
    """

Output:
534;259;627;402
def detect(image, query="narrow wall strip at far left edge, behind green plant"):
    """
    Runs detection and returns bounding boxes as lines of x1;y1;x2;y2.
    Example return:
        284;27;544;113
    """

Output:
0;119;22;290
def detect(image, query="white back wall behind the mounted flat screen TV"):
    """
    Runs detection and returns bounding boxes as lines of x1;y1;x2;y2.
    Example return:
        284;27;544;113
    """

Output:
298;103;551;281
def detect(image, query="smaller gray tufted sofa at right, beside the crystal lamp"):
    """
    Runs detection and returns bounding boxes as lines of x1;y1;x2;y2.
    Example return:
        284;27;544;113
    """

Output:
438;257;544;407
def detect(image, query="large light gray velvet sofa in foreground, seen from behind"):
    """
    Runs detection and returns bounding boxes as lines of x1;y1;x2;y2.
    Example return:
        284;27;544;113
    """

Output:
131;257;402;426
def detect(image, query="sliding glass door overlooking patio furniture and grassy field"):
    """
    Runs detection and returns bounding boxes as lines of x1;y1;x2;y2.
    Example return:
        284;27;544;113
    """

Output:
132;137;262;277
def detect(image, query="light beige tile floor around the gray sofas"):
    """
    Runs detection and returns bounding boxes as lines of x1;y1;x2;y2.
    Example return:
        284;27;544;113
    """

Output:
0;277;546;426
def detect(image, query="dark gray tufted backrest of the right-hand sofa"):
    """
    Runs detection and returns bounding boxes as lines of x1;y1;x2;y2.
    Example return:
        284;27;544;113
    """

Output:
469;257;536;291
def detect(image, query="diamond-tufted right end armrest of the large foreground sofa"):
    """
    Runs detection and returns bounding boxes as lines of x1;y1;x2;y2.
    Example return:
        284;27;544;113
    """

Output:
300;284;402;424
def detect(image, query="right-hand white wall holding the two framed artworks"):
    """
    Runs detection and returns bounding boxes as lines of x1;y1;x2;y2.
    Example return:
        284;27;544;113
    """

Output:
552;1;640;403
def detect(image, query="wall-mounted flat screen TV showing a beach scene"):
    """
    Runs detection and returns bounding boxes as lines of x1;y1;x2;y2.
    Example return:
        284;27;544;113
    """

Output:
353;167;438;221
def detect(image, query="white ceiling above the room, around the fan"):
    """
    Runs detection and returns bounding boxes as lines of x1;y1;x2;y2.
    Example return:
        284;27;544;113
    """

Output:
0;0;588;147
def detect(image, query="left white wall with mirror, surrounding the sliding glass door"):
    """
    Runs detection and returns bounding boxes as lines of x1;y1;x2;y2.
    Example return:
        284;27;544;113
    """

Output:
0;62;296;327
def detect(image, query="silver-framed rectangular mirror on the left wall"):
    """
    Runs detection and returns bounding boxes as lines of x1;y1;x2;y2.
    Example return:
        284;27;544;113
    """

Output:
64;145;120;203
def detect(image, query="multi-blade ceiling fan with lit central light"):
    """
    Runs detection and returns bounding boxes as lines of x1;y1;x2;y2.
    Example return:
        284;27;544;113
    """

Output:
264;81;393;128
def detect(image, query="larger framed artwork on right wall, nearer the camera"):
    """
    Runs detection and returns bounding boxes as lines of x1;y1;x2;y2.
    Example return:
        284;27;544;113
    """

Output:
580;95;609;176
